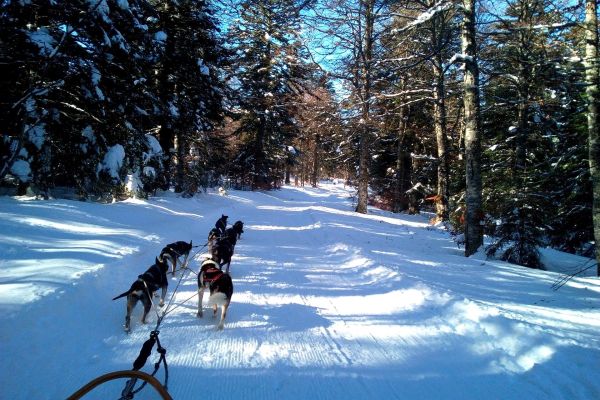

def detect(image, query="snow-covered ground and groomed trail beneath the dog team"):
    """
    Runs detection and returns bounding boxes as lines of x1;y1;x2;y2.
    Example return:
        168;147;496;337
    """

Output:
0;183;600;400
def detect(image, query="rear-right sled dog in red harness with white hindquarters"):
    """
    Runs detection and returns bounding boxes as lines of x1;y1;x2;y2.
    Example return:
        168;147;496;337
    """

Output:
196;258;233;329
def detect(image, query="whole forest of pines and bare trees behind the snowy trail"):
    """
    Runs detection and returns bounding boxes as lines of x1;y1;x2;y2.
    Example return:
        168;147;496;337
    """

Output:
0;0;600;275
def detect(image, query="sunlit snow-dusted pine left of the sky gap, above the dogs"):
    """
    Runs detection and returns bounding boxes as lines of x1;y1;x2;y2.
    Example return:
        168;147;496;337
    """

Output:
229;0;304;189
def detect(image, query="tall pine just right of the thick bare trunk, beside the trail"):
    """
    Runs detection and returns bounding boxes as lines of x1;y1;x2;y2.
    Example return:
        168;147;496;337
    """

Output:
486;1;564;268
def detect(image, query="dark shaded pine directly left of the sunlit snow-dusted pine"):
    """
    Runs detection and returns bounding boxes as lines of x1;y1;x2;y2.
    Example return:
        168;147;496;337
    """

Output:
154;0;226;194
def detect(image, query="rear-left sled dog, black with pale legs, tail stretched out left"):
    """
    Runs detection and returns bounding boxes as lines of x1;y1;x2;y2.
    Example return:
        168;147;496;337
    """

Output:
113;257;169;332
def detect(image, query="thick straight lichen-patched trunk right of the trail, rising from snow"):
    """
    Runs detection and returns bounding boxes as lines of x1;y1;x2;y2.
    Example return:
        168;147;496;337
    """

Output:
461;0;483;257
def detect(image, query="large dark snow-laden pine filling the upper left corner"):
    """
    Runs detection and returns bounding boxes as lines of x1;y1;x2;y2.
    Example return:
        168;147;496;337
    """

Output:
3;1;165;196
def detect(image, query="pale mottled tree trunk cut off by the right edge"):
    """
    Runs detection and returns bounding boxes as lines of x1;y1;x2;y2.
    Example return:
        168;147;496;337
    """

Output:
585;0;600;276
